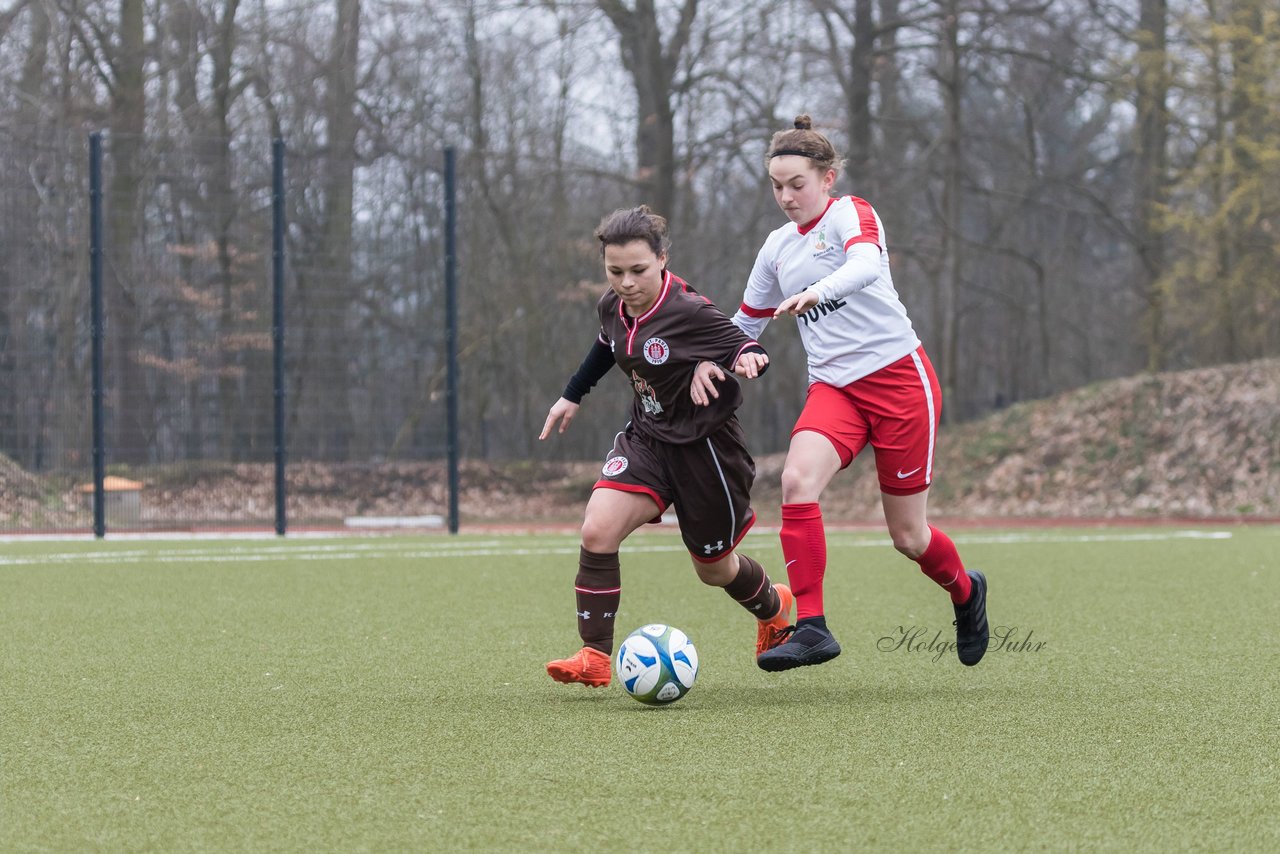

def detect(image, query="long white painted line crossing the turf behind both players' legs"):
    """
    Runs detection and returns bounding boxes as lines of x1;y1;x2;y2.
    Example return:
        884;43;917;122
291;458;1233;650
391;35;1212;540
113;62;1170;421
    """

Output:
0;530;1231;566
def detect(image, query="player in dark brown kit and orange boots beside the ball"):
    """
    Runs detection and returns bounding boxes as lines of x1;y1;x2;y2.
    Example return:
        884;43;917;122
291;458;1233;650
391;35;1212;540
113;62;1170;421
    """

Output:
538;205;792;686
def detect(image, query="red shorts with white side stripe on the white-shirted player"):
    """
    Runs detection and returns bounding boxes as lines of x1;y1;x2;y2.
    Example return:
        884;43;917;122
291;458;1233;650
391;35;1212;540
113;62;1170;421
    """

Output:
791;347;942;495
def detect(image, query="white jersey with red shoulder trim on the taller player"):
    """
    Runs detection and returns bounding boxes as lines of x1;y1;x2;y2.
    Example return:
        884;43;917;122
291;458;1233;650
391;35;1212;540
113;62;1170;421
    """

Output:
733;196;920;388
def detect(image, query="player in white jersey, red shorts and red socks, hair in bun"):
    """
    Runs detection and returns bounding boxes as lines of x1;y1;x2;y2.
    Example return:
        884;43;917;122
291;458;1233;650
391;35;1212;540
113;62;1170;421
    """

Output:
691;115;988;671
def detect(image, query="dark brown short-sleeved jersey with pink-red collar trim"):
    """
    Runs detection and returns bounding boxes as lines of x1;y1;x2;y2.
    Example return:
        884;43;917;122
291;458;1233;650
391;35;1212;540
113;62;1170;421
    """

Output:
596;271;759;444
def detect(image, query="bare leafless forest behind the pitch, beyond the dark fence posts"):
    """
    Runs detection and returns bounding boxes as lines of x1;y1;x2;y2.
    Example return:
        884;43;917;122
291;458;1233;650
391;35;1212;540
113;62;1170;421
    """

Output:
0;0;1280;522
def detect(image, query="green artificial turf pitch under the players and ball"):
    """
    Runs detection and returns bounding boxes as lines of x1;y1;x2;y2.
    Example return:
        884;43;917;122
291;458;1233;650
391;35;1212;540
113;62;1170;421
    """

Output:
0;528;1280;851
